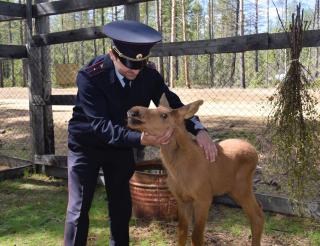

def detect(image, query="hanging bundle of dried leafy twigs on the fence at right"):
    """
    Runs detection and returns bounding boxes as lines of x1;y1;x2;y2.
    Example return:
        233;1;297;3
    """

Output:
268;4;320;207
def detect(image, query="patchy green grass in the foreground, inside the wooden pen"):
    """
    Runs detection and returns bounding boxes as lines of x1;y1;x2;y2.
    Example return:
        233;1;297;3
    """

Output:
0;175;320;246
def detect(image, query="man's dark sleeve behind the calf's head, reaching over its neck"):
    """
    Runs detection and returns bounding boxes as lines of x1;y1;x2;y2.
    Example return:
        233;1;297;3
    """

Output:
152;72;206;136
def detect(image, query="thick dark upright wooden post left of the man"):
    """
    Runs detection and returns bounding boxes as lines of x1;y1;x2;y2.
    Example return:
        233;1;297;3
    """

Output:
26;0;54;162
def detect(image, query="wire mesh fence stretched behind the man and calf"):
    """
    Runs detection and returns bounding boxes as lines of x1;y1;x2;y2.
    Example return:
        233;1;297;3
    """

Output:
0;41;320;202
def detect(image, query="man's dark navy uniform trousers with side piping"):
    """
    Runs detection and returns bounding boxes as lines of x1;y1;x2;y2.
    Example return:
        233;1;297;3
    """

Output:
64;149;134;246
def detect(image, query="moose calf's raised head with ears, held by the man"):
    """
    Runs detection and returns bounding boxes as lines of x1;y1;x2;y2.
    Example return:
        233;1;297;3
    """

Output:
127;94;203;136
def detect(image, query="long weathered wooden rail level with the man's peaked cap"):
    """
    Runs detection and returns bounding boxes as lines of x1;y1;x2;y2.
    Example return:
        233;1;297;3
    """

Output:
0;27;320;58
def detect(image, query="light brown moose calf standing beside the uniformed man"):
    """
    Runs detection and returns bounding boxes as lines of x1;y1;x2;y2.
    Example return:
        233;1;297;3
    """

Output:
128;96;264;246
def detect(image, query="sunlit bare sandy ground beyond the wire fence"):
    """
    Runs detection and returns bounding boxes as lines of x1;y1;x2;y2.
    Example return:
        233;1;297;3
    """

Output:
0;88;273;157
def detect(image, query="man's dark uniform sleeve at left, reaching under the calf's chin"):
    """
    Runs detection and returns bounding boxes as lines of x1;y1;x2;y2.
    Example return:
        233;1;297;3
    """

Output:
77;72;141;147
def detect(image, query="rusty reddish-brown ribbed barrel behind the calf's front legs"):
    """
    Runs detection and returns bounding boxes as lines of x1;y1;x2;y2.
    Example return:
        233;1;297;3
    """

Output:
130;160;178;220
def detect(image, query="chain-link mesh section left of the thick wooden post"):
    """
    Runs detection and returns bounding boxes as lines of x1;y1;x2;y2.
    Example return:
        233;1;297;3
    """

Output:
0;59;31;159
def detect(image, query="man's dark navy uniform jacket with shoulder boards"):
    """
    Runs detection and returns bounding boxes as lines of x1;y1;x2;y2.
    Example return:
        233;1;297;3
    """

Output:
68;55;200;150
